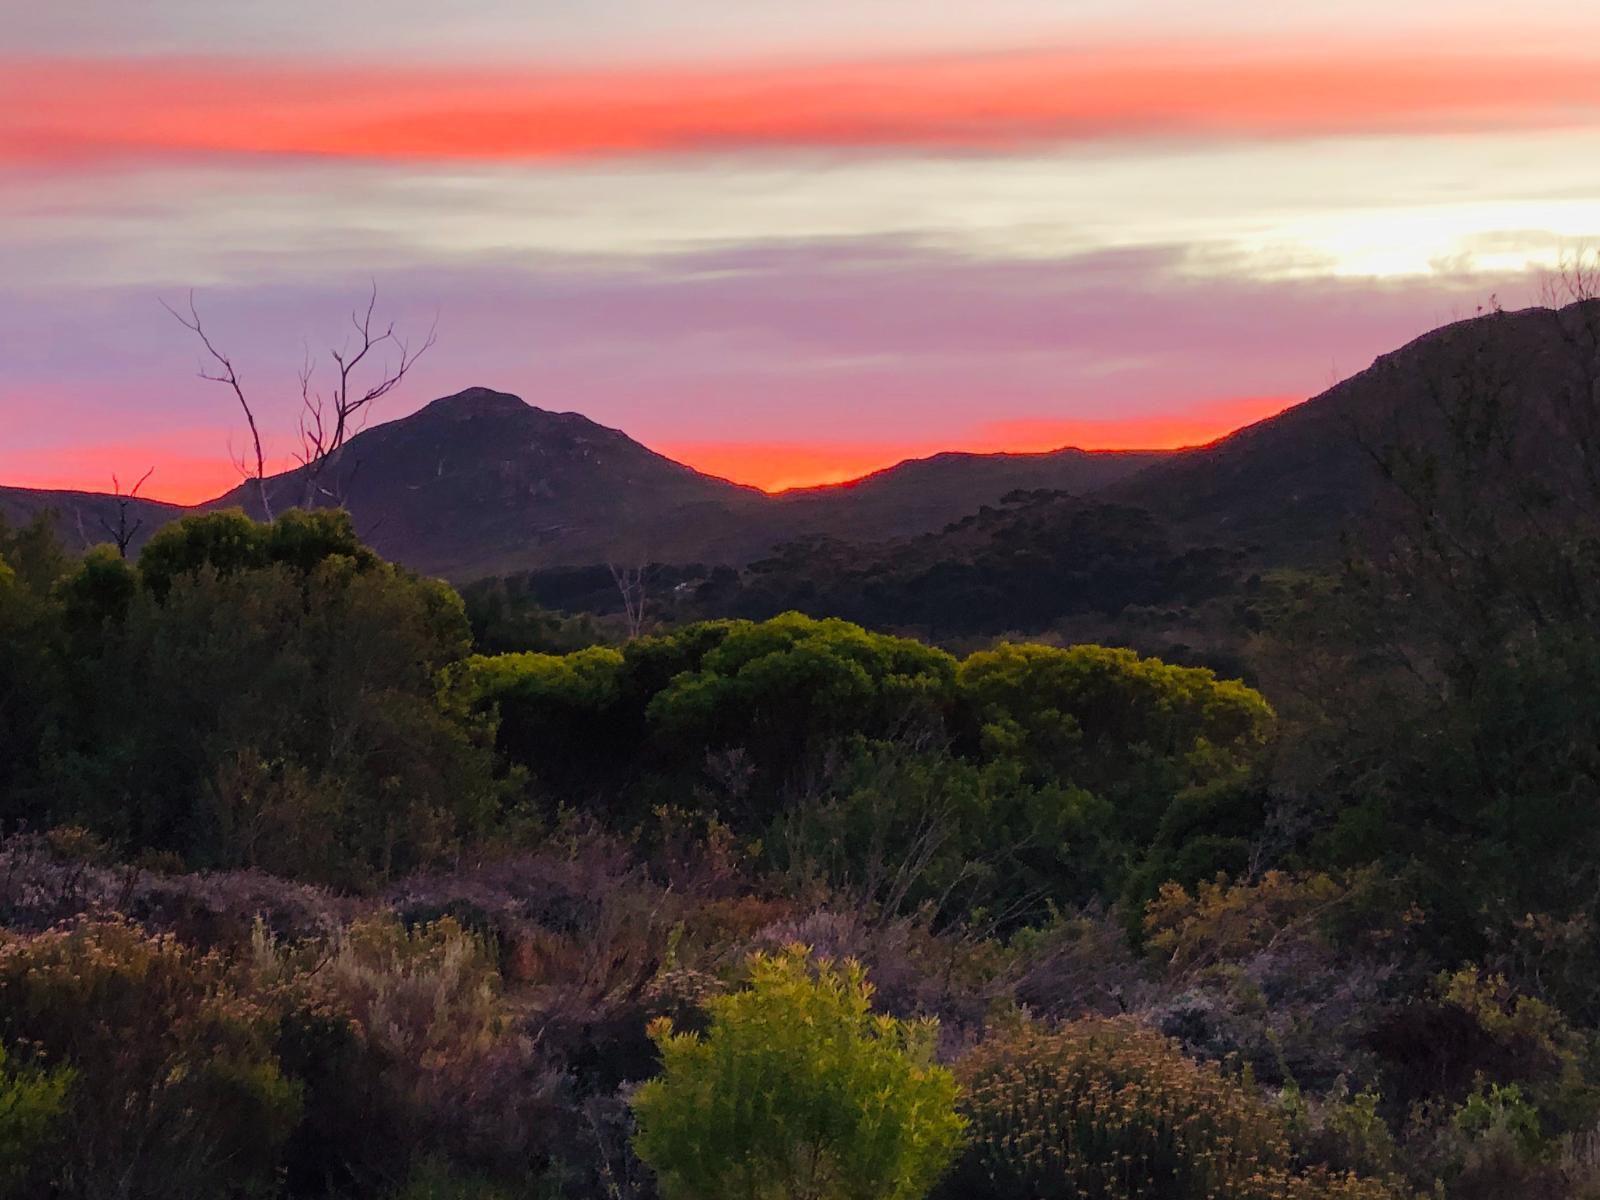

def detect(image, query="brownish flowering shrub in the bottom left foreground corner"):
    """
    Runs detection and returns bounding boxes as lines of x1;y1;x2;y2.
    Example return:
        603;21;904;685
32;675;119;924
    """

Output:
0;920;301;1200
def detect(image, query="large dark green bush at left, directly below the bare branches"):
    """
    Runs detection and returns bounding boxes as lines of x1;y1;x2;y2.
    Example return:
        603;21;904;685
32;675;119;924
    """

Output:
37;512;499;886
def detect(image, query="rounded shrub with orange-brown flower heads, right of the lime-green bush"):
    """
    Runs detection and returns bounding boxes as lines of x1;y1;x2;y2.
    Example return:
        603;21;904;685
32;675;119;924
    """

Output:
949;1018;1389;1200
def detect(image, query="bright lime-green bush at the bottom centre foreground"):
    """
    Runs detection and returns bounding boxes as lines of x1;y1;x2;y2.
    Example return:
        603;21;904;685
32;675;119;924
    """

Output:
634;947;962;1200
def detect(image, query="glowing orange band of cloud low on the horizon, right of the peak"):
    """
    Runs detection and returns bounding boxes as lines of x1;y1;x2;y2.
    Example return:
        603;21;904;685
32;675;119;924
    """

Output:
654;395;1294;491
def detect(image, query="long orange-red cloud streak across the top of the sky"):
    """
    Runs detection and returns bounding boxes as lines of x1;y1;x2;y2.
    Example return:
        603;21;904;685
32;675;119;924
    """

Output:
0;45;1600;163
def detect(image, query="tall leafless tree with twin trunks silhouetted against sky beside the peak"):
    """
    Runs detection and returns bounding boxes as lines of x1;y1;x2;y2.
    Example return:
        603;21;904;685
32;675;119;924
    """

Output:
162;283;438;520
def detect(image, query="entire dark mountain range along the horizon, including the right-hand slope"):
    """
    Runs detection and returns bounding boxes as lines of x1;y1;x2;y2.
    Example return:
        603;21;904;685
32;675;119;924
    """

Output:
9;302;1600;582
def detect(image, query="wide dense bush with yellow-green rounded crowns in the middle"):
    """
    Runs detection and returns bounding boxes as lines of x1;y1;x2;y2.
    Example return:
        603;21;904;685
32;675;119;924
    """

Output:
456;613;1272;923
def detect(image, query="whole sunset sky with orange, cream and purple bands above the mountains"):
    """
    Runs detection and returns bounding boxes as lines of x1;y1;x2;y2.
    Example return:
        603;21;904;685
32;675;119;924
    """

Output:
0;0;1600;501
